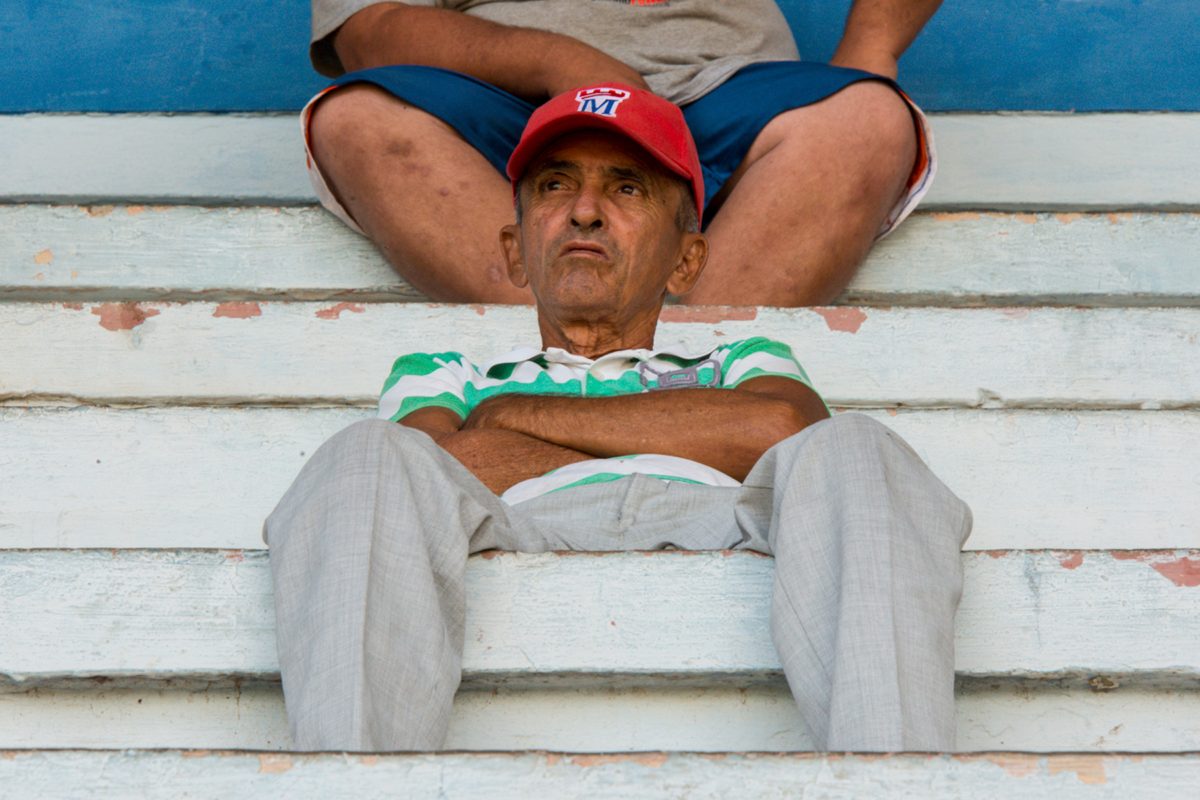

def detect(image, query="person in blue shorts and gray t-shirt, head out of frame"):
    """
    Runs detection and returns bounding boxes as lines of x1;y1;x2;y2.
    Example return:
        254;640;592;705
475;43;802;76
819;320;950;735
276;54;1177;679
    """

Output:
302;0;941;306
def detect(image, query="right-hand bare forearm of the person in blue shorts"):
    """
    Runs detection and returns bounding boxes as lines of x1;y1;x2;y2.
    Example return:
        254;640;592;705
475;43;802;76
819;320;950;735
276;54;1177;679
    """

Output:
829;0;942;79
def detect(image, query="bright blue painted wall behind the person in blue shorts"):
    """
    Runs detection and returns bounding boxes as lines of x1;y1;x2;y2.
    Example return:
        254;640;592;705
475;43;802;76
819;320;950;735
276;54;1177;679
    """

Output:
0;0;1200;113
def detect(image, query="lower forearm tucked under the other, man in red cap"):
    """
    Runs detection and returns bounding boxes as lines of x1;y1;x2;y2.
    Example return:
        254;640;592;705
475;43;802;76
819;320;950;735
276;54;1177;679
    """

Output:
434;428;592;494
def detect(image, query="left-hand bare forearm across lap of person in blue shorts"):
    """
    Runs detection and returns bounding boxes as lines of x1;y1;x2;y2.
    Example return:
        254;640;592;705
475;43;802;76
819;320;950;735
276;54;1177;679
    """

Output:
334;4;646;102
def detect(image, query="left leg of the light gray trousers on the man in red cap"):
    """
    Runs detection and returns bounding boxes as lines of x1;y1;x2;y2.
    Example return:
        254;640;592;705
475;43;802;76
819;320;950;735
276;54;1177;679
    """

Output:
264;420;548;750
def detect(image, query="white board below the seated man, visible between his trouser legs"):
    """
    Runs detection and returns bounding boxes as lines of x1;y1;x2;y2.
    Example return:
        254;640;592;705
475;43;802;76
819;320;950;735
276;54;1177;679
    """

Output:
0;551;1200;688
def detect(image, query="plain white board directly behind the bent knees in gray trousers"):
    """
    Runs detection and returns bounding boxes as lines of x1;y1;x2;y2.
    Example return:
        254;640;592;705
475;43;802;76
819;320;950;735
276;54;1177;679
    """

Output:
0;407;1200;549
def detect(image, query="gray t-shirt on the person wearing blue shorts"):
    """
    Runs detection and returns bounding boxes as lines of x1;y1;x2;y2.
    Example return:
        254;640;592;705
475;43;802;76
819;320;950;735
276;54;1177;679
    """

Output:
310;0;800;106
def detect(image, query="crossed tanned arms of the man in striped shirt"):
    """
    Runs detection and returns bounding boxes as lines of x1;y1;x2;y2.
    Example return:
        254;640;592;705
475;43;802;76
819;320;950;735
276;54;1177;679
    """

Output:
401;377;829;494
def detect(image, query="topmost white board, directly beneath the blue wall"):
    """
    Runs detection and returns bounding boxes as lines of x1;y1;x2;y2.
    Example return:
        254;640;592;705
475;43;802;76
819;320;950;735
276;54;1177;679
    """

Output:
0;113;1200;210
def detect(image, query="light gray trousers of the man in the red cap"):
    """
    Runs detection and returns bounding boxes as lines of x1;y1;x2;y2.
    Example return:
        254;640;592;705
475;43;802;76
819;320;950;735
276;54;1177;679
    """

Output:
264;414;971;751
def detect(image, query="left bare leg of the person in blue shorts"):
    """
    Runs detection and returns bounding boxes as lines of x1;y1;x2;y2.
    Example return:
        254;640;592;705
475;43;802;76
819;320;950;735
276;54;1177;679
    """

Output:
311;84;533;303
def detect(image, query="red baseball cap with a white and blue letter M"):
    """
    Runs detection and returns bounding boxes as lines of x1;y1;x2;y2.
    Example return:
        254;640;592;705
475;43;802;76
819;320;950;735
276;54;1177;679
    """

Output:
508;83;704;217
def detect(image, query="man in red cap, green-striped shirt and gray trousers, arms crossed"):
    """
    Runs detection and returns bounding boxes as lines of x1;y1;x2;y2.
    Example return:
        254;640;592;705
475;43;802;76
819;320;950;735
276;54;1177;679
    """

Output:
265;90;971;751
